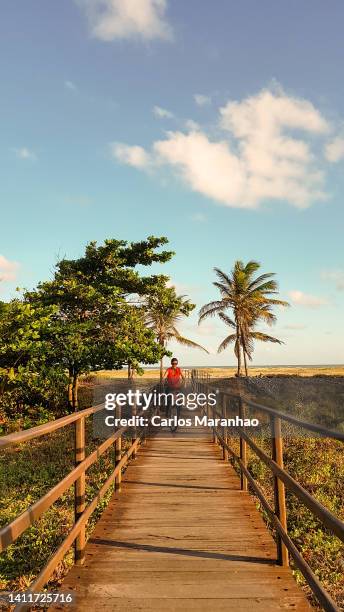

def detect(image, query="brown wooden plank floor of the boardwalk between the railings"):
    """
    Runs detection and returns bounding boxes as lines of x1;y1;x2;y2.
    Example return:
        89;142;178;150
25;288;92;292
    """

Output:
54;420;311;612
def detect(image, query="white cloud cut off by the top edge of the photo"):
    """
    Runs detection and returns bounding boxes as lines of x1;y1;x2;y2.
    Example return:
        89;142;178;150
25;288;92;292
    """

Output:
76;0;172;41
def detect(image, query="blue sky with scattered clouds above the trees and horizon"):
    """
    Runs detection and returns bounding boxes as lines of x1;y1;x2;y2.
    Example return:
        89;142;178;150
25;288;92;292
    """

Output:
0;0;344;365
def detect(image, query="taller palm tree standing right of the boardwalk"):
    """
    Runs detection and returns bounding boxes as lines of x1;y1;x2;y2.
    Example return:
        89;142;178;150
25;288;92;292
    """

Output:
199;260;289;376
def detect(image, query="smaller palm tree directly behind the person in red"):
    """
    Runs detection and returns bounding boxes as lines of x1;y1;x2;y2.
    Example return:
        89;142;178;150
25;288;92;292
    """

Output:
146;287;208;381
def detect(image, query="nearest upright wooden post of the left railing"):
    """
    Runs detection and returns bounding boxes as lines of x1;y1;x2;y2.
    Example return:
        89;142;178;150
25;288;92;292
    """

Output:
74;417;86;565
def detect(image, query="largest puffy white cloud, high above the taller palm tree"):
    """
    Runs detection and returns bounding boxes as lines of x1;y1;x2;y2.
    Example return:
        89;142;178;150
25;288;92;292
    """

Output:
111;90;329;208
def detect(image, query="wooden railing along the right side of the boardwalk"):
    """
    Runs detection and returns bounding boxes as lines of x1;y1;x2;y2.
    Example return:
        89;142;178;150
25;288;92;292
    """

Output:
191;370;344;612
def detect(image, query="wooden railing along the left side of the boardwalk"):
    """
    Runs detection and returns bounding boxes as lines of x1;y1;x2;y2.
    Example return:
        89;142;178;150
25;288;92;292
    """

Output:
0;405;145;611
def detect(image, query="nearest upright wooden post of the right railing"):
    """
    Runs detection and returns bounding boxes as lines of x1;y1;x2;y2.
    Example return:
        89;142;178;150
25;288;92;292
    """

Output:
270;415;289;567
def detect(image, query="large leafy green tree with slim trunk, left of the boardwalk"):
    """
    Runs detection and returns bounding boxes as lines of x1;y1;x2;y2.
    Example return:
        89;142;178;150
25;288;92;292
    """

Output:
26;236;173;410
